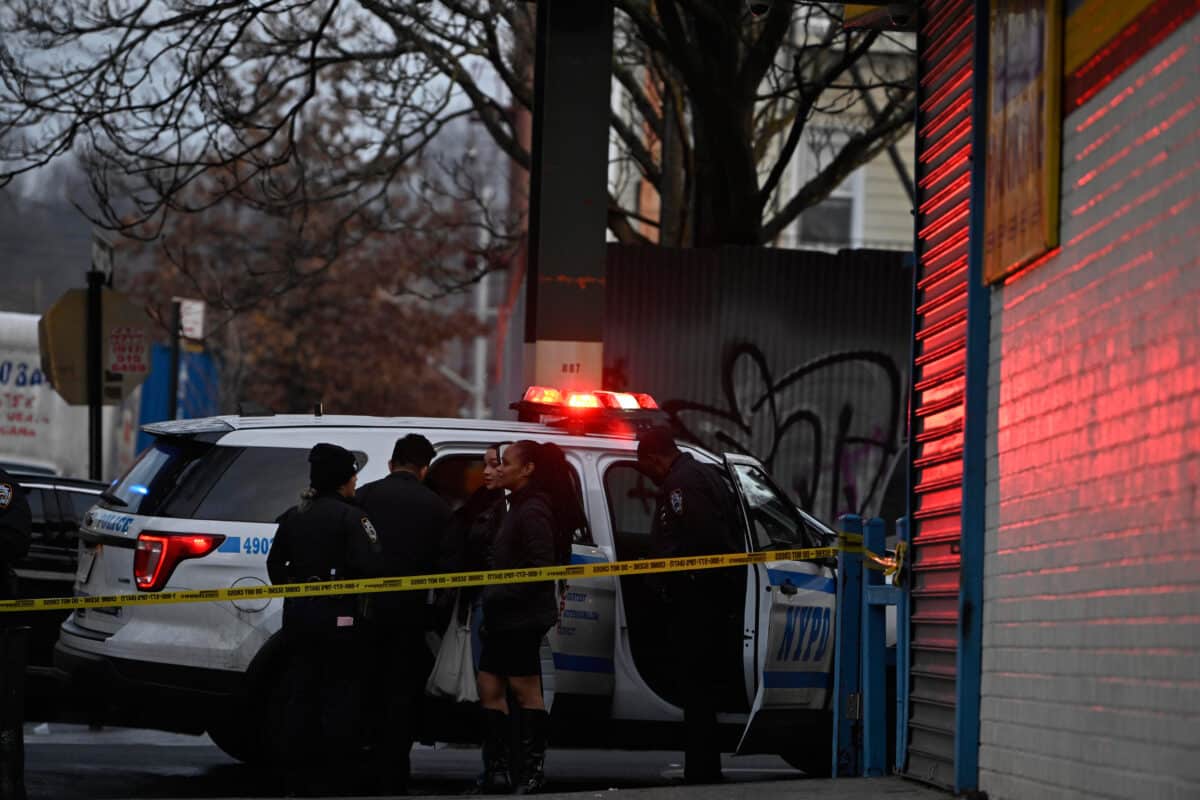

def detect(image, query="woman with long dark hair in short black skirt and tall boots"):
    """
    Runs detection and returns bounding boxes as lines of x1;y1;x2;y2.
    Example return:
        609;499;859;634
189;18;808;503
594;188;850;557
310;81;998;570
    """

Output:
476;439;558;794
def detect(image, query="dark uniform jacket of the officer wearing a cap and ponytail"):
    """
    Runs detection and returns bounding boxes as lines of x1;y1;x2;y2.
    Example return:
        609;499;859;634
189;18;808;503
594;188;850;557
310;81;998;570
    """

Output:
266;492;379;633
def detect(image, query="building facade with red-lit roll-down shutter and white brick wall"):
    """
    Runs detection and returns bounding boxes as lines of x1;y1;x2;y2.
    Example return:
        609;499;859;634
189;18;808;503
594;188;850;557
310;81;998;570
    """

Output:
898;0;1200;799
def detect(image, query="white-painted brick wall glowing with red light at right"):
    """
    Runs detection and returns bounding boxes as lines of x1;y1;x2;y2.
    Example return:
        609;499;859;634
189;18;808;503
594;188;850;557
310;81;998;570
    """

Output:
979;17;1200;800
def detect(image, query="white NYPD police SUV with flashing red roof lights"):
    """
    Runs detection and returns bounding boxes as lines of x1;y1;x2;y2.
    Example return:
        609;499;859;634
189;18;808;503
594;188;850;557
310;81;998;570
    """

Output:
55;387;835;774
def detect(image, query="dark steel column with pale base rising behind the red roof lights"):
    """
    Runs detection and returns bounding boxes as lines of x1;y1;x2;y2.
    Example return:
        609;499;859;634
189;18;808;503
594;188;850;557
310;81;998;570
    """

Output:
524;0;613;390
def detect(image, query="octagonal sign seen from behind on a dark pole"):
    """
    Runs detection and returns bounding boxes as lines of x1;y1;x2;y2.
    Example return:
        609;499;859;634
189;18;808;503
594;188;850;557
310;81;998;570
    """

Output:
37;289;151;405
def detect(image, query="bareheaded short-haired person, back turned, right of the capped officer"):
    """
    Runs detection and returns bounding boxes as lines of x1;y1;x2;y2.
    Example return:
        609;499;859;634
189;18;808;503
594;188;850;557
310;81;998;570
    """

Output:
358;433;450;793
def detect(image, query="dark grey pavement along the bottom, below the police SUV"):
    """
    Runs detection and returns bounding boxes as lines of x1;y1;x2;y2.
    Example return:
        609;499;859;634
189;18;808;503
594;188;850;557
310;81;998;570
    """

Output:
25;723;949;800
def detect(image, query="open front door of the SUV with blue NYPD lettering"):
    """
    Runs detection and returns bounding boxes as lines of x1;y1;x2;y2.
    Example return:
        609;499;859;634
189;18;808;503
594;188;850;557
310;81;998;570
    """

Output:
725;455;836;763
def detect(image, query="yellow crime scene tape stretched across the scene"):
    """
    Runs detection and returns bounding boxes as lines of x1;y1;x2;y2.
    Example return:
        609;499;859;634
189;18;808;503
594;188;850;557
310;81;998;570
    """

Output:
0;534;899;613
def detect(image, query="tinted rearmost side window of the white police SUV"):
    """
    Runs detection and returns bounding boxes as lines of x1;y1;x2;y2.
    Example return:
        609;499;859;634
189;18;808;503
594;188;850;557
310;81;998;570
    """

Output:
192;447;314;522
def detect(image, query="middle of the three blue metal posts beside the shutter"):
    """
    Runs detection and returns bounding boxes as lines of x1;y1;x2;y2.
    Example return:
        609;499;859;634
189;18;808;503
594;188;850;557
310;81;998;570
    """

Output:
862;517;894;777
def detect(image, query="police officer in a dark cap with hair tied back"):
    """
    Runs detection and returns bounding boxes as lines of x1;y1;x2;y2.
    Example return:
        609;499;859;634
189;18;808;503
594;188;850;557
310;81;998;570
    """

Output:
266;444;379;793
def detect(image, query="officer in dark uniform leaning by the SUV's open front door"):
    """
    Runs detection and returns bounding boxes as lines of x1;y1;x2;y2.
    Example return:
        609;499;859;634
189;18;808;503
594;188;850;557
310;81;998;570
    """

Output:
637;428;745;783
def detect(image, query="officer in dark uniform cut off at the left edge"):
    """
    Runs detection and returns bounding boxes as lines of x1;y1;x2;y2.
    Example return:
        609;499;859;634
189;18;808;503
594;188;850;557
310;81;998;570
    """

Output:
0;468;34;798
